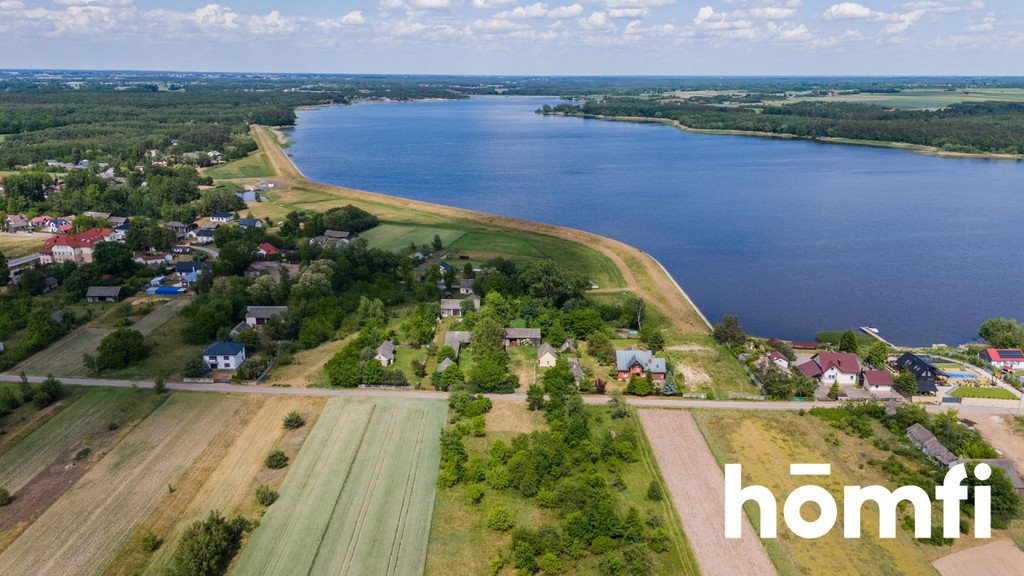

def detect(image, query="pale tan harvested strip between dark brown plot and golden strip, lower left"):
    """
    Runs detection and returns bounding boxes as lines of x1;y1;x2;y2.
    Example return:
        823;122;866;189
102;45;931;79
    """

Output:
0;395;242;574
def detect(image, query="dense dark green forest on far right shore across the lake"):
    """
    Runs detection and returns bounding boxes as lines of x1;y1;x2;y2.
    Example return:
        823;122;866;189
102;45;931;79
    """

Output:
544;98;1024;154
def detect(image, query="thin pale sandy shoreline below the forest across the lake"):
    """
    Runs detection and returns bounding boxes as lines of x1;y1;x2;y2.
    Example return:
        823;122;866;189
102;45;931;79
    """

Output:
540;112;1024;162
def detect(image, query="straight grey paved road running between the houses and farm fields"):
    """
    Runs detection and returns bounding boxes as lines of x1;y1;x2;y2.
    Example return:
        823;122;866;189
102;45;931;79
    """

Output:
0;374;1016;414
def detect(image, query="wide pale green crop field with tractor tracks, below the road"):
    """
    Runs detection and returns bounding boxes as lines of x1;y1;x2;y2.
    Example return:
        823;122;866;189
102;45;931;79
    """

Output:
233;398;446;576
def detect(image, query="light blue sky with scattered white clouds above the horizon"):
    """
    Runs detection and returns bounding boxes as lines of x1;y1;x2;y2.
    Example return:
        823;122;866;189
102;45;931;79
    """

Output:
0;0;1024;75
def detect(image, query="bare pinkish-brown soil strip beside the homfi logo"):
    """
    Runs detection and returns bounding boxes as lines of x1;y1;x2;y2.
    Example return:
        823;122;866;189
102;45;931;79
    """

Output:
638;410;774;576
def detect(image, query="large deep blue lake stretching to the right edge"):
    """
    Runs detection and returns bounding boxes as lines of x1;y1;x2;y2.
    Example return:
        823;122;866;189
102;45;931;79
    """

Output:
288;97;1024;344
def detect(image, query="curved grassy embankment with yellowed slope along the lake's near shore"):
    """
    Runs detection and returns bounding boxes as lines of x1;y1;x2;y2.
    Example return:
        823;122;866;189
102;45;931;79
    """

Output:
220;126;754;396
